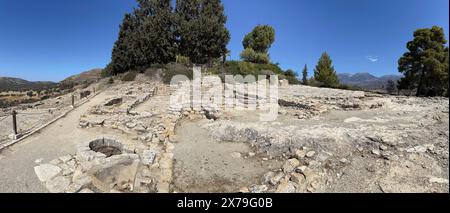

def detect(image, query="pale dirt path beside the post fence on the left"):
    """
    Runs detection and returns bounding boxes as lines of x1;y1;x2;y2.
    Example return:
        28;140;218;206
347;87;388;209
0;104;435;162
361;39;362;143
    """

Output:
0;93;115;192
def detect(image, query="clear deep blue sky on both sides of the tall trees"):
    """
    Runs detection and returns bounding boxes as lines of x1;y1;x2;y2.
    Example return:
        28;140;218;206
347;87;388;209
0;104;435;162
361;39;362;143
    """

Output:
0;0;449;81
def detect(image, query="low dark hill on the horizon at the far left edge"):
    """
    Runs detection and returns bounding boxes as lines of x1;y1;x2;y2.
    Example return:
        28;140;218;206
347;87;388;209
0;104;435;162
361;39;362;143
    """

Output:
0;77;57;91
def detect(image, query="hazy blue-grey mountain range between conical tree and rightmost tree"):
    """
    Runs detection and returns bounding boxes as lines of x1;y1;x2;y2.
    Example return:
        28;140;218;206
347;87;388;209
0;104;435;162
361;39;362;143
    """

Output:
338;73;402;90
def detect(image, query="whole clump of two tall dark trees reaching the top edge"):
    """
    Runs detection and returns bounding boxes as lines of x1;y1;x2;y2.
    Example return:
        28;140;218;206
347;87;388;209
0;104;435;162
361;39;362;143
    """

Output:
106;0;230;75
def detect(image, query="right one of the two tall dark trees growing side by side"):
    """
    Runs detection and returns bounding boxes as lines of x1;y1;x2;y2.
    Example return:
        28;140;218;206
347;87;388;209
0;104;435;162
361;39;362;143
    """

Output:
175;0;230;64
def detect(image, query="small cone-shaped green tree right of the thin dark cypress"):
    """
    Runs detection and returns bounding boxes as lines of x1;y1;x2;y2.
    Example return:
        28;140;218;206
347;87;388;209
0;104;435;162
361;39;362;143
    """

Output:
314;52;339;87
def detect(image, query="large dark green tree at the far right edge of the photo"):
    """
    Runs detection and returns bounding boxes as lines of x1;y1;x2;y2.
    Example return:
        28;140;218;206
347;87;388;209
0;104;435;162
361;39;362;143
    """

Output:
398;26;449;96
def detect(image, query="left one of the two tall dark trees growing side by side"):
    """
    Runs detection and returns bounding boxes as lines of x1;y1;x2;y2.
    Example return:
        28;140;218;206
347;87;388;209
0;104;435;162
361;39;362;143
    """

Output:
107;0;176;74
